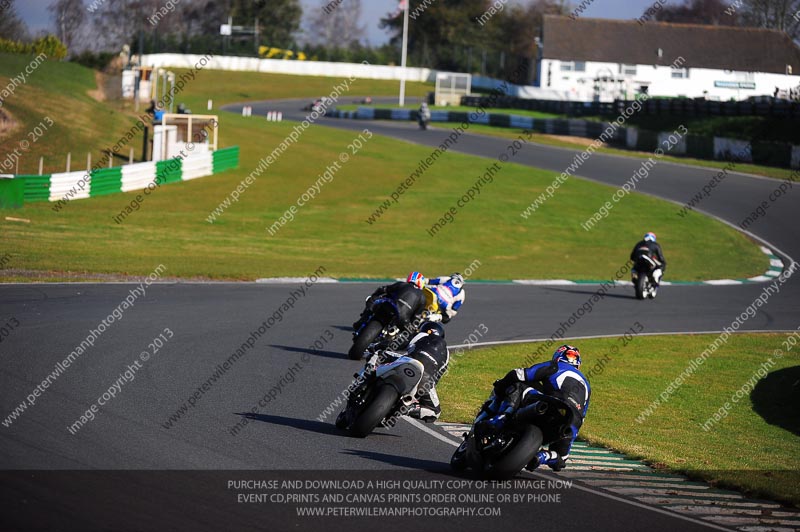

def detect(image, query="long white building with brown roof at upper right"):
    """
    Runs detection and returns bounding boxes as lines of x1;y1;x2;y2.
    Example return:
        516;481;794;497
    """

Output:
536;15;800;101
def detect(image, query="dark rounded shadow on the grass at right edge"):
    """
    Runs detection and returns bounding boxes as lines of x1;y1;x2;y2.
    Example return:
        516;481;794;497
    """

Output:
750;366;800;436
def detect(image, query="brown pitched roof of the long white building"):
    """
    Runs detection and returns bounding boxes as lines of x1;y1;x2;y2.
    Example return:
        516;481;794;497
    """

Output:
542;15;800;75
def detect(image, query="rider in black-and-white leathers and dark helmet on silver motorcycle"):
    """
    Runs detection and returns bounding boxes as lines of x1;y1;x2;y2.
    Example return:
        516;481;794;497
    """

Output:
388;321;450;423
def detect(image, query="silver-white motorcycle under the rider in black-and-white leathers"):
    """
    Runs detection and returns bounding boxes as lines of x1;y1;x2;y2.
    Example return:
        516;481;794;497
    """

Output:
336;351;425;438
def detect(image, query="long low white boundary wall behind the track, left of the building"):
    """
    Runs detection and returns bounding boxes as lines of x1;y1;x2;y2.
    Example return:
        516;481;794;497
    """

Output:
142;54;436;82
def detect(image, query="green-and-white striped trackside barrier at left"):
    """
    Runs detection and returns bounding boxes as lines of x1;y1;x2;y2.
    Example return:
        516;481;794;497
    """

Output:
0;146;239;208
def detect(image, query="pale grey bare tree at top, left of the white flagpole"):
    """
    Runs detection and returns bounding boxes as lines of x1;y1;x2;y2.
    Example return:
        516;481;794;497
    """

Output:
307;0;365;48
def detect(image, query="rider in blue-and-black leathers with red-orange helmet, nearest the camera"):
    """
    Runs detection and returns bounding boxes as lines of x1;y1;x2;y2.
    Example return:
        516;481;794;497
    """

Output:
479;344;592;471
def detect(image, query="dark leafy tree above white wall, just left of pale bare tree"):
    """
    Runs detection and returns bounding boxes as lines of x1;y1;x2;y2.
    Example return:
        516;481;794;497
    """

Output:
230;0;303;48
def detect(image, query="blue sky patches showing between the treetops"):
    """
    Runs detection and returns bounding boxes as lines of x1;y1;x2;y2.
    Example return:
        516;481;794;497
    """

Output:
16;0;660;45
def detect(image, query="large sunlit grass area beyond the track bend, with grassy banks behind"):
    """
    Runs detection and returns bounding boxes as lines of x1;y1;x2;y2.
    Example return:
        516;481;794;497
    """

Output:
0;57;767;280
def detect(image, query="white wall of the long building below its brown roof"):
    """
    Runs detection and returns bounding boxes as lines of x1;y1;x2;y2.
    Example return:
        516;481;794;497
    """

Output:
541;59;800;101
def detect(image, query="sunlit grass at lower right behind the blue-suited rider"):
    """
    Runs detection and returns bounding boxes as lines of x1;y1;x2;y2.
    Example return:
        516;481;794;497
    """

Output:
437;334;800;506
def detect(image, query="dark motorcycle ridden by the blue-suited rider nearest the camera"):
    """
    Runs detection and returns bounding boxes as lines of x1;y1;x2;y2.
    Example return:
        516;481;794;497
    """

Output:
450;392;575;480
